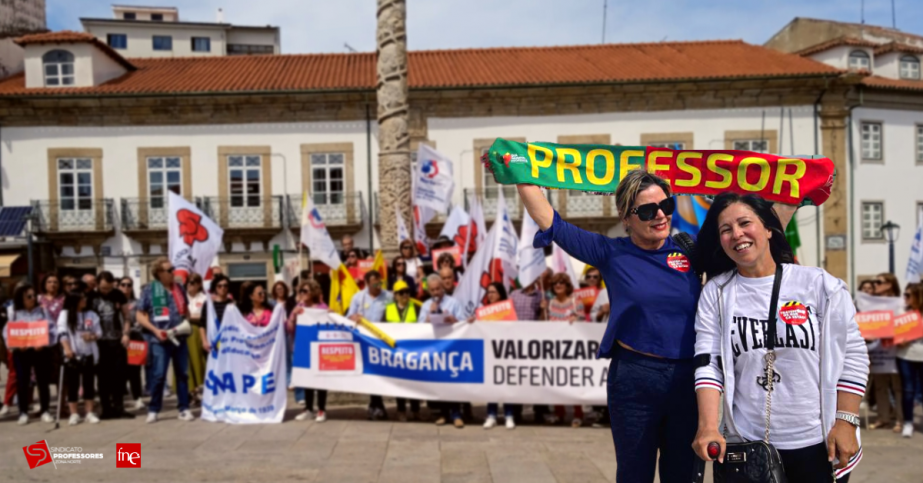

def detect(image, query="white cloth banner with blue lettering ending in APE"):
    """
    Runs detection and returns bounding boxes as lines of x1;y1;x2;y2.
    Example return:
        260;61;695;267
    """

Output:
202;304;287;424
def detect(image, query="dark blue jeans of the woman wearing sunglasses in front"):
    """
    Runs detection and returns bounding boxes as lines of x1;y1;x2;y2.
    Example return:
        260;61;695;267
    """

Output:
606;348;700;483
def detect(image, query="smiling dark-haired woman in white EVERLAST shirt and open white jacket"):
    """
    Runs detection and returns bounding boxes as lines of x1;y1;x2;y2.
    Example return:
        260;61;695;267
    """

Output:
693;193;868;482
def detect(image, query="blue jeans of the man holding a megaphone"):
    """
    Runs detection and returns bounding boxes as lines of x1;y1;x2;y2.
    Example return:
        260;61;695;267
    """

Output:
147;337;189;413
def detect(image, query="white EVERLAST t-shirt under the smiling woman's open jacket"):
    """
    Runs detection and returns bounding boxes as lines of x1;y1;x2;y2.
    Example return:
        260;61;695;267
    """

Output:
729;275;823;450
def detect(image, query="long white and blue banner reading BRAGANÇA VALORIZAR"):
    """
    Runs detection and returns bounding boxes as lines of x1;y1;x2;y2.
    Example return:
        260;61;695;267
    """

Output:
292;309;609;405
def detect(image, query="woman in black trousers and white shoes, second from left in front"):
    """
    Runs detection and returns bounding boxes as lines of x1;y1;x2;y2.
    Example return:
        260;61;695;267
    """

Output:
57;290;103;426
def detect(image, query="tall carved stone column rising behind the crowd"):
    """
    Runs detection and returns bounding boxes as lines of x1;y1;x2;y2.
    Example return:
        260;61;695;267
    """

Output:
378;0;413;258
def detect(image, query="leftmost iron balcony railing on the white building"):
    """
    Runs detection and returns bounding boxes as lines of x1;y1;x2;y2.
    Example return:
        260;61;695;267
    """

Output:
32;198;116;233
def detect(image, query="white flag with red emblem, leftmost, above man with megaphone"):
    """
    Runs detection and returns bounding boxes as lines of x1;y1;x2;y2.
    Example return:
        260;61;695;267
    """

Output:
167;191;224;280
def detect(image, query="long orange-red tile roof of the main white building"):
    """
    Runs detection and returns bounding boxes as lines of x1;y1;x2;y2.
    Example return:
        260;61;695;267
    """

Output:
0;40;842;96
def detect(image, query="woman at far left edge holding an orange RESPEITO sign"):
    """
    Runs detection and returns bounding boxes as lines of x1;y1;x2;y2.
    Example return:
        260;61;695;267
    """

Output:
3;283;57;424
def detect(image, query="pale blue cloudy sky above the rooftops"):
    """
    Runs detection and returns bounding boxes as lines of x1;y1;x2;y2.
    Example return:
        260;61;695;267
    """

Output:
47;0;923;53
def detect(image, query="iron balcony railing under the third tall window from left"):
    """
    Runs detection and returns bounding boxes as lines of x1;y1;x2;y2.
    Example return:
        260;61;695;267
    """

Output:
201;196;285;228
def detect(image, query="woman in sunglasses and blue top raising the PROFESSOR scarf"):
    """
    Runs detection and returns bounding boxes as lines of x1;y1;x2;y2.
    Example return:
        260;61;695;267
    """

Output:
517;169;795;482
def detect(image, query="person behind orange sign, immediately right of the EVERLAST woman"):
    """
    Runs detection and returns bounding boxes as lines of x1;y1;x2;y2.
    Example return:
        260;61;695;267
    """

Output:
868;273;904;433
